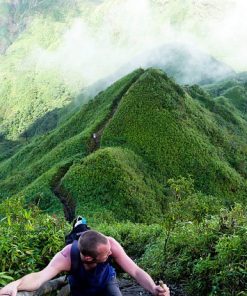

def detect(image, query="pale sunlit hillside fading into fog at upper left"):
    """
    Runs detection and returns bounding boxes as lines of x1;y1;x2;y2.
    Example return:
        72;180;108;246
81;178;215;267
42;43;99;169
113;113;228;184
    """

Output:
0;0;85;146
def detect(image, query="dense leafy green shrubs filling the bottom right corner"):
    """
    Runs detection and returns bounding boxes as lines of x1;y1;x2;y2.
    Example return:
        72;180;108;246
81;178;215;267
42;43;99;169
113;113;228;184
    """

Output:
140;204;247;296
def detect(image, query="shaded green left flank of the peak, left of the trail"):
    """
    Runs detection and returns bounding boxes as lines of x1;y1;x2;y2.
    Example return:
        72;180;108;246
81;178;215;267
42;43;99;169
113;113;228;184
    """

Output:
0;70;143;213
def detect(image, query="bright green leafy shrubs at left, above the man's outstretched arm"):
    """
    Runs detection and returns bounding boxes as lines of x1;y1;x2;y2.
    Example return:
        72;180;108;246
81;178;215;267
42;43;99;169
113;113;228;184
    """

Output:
0;198;68;279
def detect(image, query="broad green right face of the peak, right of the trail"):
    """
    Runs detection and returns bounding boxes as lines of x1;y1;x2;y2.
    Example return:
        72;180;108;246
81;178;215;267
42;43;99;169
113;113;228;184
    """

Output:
102;70;247;198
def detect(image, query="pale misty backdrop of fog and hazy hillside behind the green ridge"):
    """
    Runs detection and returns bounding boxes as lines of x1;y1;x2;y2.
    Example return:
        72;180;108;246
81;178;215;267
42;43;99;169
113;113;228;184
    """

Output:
0;0;247;139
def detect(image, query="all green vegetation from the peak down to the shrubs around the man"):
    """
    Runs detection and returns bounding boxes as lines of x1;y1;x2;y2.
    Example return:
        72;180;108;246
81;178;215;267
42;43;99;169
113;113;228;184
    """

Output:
0;69;247;295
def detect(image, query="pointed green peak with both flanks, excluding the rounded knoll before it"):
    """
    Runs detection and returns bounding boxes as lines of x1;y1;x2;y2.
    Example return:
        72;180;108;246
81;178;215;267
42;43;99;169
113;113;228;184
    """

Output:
0;69;246;213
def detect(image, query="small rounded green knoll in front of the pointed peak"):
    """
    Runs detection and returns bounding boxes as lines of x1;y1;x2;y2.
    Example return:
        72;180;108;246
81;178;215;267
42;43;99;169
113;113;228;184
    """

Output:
62;148;163;223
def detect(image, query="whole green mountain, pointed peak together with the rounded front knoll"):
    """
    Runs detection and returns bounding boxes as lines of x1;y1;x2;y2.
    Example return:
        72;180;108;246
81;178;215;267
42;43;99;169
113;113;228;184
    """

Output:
0;69;247;221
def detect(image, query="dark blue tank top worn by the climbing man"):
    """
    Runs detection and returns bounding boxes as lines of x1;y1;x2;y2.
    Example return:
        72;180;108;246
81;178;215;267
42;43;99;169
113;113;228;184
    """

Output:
68;241;116;296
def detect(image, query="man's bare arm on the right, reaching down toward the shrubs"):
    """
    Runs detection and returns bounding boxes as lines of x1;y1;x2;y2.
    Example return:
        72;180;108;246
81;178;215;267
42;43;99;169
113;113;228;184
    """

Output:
108;238;170;296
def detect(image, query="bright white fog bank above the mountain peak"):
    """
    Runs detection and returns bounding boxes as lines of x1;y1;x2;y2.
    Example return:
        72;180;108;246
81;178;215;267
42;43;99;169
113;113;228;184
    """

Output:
17;0;247;88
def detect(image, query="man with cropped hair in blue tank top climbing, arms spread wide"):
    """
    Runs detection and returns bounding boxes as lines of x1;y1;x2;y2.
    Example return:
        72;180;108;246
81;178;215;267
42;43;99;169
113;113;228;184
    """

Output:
0;230;170;296
